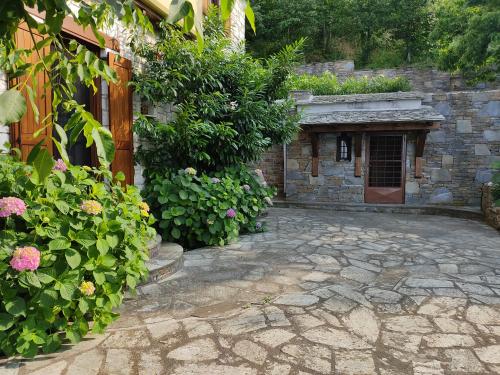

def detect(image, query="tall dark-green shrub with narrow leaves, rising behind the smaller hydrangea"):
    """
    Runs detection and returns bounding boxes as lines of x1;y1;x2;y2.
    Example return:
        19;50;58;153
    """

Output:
134;14;300;173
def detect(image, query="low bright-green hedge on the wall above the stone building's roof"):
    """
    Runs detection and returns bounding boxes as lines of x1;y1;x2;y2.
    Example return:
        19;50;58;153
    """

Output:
285;72;411;95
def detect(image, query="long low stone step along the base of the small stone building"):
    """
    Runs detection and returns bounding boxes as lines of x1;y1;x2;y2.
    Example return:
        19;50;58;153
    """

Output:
273;200;484;220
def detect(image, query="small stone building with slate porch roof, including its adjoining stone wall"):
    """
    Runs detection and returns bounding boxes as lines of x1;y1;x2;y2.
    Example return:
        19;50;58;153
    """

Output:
259;64;500;207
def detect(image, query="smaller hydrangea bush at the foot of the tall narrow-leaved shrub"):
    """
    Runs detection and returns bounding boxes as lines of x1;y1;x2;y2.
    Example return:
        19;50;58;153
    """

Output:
144;168;275;248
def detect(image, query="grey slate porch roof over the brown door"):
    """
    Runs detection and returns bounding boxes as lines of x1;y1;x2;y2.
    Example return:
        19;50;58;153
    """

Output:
300;106;444;126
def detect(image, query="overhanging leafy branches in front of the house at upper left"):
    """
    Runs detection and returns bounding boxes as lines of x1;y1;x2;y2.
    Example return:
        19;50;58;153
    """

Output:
0;0;253;181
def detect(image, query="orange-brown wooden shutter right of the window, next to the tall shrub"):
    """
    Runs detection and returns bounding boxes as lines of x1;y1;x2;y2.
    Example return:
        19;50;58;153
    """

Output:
108;53;134;184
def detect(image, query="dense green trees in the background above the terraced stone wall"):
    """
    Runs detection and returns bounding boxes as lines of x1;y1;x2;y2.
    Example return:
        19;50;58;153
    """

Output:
247;0;500;80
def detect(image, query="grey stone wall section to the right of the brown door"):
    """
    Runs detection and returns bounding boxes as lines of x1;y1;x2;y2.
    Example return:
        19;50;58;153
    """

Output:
406;90;500;206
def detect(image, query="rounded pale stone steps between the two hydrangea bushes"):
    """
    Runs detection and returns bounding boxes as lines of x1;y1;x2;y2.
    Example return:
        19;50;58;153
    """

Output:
146;242;184;283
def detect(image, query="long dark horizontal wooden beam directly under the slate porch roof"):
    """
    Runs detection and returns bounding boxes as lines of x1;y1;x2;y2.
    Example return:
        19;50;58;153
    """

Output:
302;122;439;133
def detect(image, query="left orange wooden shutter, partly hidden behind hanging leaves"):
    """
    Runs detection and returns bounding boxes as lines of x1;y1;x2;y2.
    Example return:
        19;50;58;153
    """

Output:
10;24;52;160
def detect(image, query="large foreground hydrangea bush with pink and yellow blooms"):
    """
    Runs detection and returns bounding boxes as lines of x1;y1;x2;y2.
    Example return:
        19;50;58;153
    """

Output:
0;155;154;357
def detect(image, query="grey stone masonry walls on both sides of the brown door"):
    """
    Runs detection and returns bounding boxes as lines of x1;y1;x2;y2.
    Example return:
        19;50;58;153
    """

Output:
259;63;500;207
